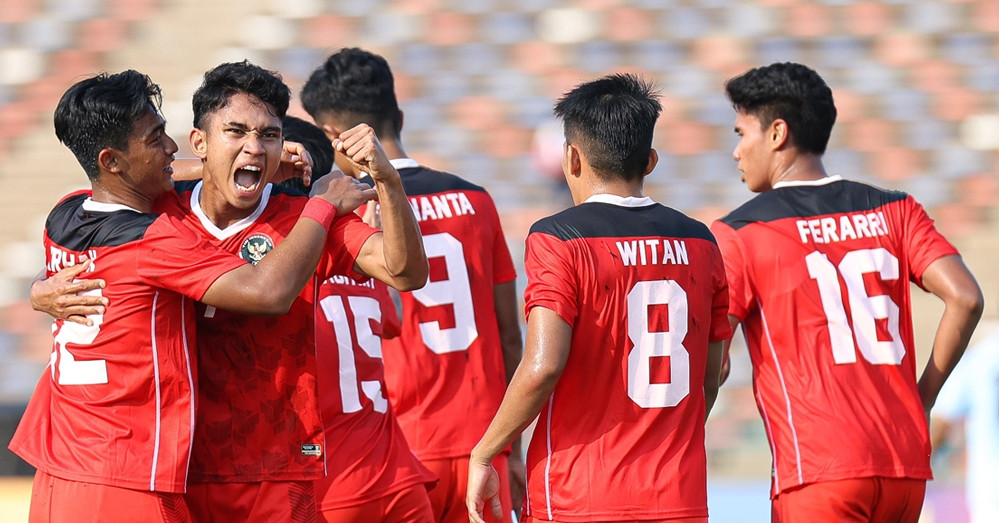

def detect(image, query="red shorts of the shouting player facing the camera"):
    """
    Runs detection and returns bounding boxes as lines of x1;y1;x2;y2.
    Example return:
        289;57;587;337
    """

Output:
184;481;316;523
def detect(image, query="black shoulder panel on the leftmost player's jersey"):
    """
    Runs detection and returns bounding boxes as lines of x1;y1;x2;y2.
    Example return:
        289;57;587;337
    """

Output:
45;194;159;252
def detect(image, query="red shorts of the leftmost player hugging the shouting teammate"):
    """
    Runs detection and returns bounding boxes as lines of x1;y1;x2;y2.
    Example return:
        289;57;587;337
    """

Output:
28;470;193;523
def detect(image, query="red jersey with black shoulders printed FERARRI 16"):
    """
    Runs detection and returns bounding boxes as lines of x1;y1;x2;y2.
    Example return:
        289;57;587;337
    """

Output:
713;177;957;495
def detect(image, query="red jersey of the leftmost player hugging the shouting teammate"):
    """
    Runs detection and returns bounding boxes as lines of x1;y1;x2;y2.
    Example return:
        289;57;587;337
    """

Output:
10;191;244;492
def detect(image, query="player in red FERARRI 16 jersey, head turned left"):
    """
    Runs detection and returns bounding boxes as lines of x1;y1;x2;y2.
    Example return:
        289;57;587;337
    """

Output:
713;63;983;522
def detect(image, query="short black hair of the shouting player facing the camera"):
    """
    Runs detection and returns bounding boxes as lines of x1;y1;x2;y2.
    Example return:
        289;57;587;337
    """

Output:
193;60;291;129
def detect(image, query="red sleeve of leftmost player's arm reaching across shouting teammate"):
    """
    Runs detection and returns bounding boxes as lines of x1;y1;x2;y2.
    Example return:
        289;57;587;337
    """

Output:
135;214;246;301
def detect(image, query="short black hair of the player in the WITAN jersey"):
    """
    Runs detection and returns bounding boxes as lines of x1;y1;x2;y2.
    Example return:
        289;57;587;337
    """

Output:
555;74;662;181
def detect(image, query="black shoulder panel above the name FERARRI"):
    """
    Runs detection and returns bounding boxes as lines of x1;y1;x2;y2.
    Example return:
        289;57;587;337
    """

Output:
721;180;908;229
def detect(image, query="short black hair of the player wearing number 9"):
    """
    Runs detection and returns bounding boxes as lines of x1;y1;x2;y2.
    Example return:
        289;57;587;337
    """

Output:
301;47;402;139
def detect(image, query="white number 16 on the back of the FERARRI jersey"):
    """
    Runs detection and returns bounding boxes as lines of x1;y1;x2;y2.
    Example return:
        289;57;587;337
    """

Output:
805;247;905;365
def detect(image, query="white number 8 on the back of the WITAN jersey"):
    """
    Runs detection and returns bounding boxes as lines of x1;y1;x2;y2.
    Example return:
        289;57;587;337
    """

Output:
628;280;690;409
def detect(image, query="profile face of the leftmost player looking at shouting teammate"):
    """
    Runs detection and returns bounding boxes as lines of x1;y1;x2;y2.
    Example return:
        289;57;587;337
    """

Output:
122;108;177;198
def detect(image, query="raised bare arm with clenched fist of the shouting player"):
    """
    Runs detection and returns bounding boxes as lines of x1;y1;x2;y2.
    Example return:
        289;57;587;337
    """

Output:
333;124;430;291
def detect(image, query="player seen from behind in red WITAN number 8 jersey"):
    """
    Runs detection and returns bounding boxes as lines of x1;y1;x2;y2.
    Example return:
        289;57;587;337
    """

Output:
466;75;731;522
